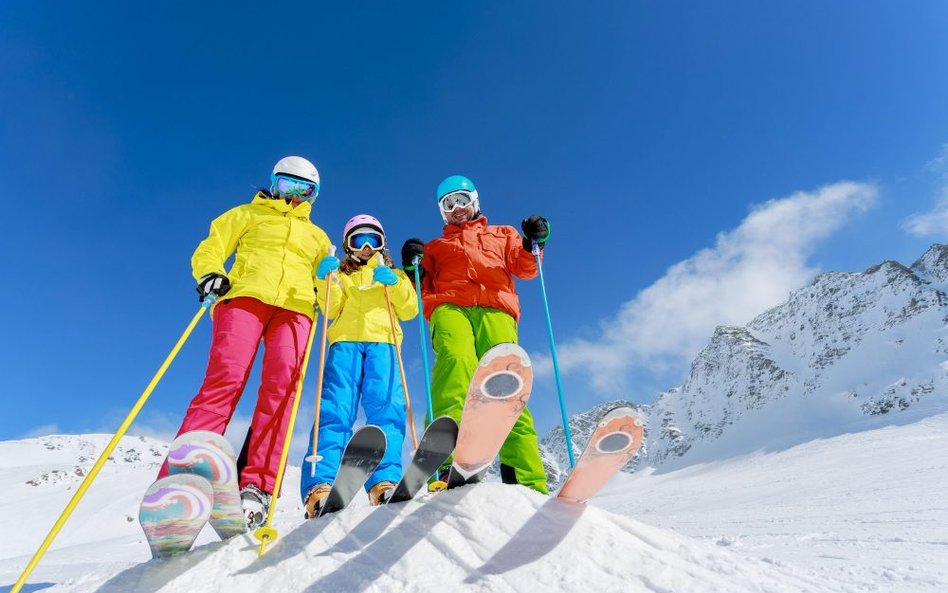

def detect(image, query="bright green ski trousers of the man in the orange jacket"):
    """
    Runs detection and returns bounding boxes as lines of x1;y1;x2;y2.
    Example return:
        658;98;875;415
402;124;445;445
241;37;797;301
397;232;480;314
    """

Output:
431;304;548;494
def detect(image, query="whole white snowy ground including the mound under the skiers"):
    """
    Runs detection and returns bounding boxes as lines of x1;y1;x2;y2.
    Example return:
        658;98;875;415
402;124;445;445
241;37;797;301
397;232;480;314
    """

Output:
0;399;948;593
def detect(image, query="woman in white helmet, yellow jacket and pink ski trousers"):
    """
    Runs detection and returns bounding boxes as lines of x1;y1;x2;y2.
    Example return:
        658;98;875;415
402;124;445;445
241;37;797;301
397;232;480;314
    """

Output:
159;156;330;530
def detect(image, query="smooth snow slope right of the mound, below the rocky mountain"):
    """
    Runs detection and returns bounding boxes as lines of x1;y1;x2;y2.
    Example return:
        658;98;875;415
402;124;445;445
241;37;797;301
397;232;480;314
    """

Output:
595;406;948;593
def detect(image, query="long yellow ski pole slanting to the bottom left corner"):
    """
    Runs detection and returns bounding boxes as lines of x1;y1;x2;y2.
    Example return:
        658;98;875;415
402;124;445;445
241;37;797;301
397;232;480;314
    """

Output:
10;295;217;593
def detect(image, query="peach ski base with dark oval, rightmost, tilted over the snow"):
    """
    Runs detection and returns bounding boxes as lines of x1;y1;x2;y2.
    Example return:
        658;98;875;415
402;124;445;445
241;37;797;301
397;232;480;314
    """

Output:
557;407;645;502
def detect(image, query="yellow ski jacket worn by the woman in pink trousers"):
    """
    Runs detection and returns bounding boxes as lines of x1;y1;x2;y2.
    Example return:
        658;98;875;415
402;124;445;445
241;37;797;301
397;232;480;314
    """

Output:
191;192;330;319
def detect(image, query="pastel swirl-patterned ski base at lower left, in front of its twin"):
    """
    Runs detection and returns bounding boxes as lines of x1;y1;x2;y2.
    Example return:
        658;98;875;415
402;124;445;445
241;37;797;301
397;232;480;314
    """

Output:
138;474;214;558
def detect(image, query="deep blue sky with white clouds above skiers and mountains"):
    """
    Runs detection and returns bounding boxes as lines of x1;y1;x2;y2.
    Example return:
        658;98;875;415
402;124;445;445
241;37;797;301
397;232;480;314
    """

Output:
0;0;948;454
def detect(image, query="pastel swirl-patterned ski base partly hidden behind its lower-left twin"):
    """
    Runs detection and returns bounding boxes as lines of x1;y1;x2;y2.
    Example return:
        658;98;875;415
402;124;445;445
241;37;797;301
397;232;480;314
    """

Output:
168;430;247;540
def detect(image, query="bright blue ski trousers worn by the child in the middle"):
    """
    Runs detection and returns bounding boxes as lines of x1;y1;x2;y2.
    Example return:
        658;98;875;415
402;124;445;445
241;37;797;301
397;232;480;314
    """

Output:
300;342;405;501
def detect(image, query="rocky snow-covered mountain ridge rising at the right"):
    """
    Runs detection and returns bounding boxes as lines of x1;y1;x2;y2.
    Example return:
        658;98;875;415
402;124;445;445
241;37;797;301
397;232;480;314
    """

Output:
542;240;948;481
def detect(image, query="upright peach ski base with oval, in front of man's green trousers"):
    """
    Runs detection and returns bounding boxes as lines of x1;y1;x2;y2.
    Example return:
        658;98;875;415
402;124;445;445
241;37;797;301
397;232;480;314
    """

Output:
448;344;533;488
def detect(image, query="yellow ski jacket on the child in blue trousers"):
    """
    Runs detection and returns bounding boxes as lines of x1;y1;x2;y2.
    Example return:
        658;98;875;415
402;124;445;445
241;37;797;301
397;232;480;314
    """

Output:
317;257;418;344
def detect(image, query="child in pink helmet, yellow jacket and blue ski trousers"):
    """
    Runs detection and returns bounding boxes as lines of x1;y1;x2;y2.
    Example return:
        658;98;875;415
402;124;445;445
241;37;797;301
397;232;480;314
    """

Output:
300;214;418;517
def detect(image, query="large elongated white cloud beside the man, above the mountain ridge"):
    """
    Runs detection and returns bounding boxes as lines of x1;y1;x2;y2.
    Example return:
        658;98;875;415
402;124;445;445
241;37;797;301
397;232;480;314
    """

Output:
537;182;877;391
